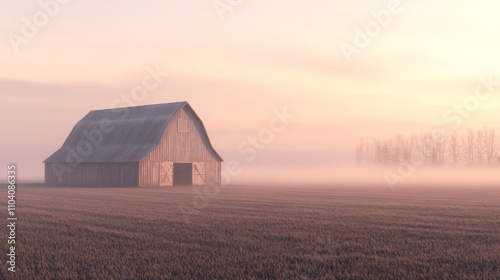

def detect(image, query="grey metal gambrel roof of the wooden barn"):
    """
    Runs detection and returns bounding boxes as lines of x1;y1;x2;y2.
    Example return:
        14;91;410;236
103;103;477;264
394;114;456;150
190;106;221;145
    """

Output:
44;101;222;163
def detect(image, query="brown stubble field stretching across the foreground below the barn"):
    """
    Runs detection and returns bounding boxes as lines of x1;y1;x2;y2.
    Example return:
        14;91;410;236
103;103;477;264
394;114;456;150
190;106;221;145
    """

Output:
0;185;500;279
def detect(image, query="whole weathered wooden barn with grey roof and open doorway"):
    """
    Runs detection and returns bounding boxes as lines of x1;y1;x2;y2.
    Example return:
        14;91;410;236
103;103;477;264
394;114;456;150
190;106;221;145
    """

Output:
44;102;223;187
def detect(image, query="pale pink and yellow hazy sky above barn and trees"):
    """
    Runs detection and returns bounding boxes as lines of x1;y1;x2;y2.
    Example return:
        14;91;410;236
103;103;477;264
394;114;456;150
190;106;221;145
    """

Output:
0;0;500;183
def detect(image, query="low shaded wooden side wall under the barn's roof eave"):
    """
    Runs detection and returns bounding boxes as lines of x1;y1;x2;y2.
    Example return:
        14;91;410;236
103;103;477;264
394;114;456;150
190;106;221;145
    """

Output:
45;163;139;187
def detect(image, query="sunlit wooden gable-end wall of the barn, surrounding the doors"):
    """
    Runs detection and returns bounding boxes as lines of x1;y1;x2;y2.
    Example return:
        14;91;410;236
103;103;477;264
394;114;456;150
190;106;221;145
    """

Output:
139;107;221;186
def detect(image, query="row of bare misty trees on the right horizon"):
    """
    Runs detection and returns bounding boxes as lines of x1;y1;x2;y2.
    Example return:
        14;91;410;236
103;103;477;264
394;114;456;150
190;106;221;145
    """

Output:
356;127;500;166
